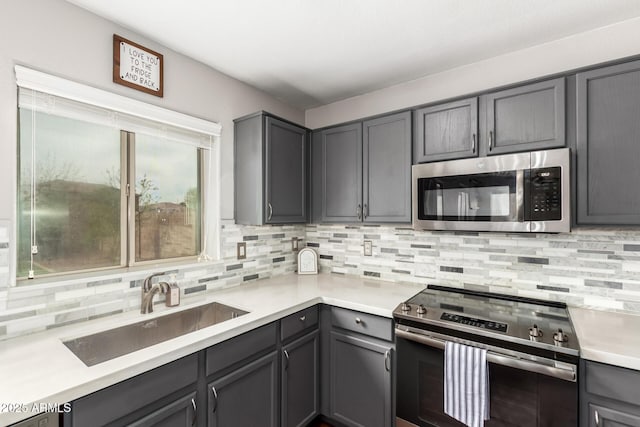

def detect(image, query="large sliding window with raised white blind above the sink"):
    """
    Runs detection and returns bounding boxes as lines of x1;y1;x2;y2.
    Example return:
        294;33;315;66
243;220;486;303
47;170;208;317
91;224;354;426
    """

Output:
16;67;220;278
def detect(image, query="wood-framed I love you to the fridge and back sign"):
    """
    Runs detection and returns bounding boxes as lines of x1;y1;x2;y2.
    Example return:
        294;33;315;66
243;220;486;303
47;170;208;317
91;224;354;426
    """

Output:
113;34;163;97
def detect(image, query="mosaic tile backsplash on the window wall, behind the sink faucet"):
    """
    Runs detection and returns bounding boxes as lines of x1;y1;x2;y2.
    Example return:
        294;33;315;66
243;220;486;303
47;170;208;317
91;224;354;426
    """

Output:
0;221;305;340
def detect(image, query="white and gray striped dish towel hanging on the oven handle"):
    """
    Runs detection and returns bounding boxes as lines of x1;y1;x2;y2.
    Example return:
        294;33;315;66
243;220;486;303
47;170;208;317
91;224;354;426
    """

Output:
444;341;490;427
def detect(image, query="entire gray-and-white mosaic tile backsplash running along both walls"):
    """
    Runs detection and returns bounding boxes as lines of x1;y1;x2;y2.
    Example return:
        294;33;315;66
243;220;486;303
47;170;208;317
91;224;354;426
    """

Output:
0;221;640;340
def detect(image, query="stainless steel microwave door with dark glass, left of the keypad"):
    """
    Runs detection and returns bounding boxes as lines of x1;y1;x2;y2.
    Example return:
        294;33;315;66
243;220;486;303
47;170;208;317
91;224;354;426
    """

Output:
412;153;530;231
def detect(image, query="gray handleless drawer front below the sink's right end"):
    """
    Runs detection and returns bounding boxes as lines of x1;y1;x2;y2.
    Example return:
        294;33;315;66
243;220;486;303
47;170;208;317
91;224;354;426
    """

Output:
206;322;278;375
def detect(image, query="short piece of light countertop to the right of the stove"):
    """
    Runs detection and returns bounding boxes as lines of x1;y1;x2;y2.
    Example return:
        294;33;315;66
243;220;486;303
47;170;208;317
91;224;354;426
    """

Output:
569;307;640;370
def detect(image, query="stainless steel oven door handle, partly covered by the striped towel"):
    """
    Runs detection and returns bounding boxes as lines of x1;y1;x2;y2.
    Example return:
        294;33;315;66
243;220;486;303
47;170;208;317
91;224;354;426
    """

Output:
396;328;576;382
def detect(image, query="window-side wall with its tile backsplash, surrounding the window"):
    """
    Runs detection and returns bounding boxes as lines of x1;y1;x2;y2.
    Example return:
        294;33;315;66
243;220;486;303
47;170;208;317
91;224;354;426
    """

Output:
0;0;304;339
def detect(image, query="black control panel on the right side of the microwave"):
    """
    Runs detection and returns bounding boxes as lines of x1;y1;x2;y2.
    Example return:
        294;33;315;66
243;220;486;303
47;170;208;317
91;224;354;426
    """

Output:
524;167;562;221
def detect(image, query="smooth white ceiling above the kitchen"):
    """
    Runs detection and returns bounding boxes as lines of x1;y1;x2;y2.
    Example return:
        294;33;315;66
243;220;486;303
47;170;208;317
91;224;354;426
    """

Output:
67;0;640;109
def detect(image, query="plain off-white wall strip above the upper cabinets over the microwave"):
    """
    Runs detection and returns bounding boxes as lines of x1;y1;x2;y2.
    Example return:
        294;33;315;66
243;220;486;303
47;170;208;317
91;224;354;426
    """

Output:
305;18;640;129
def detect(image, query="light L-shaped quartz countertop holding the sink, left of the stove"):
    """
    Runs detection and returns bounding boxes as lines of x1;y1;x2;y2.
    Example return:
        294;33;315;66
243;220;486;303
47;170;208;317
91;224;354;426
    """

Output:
0;274;424;426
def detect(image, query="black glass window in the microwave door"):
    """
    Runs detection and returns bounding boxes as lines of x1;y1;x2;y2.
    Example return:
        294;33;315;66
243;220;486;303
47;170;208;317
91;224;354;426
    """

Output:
418;171;520;221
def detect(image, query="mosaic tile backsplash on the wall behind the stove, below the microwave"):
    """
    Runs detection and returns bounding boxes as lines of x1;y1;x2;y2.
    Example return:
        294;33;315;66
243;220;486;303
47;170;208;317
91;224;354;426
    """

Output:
306;225;640;313
